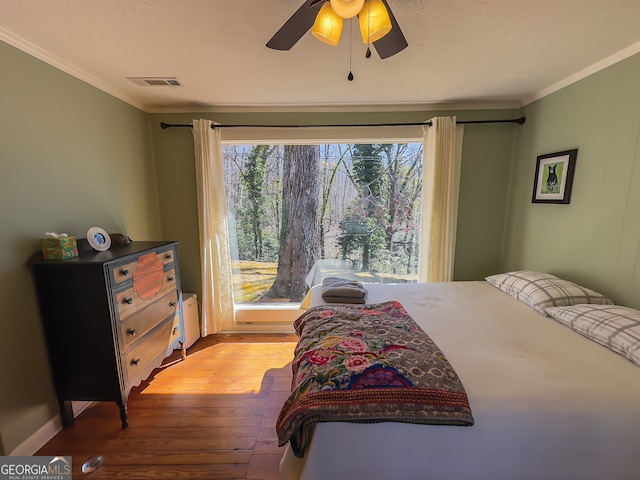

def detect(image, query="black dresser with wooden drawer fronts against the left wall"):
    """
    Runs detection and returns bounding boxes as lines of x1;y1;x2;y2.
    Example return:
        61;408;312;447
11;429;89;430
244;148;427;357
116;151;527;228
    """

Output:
29;242;186;428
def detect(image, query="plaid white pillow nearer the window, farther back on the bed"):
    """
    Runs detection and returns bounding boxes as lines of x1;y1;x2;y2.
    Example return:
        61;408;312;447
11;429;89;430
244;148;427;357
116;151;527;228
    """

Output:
485;270;613;316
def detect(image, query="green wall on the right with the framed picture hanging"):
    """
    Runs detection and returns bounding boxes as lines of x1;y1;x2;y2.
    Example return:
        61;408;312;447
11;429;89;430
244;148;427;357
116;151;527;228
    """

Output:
501;51;640;308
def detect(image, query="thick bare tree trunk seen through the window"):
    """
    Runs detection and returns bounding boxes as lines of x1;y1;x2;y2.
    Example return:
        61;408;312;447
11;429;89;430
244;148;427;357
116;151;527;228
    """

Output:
265;145;320;302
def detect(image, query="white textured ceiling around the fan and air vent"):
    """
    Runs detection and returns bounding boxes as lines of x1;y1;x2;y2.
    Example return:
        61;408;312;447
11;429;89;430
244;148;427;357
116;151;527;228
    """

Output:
0;0;640;112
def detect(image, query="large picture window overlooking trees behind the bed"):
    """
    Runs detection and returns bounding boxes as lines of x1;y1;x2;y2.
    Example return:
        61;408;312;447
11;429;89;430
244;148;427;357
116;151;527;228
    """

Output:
223;142;423;306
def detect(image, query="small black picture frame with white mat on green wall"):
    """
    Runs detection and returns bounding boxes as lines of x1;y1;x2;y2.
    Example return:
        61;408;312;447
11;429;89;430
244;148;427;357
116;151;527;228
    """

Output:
531;148;578;204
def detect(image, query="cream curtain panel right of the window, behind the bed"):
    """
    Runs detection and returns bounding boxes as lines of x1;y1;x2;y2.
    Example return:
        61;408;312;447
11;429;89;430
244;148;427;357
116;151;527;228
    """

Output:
418;117;464;282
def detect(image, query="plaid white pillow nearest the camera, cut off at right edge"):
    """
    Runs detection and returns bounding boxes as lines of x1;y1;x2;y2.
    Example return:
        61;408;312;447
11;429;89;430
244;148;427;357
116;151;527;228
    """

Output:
547;305;640;365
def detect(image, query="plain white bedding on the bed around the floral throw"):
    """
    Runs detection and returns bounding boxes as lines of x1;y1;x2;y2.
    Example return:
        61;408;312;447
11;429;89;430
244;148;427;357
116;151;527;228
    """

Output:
280;282;640;480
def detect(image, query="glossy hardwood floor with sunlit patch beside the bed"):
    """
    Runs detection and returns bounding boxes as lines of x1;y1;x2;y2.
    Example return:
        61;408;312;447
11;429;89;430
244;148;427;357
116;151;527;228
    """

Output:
36;334;297;480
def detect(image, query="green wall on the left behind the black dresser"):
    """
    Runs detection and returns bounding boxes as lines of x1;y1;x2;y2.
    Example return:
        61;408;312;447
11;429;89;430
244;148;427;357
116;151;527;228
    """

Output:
0;42;162;455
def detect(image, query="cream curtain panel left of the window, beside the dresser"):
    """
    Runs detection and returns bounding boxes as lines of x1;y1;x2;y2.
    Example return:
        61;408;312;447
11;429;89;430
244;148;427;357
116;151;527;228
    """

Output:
193;120;235;336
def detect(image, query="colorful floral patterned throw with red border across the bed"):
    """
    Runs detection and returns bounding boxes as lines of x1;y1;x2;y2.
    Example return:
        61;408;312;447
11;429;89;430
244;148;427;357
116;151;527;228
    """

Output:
276;301;473;457
